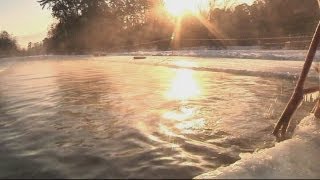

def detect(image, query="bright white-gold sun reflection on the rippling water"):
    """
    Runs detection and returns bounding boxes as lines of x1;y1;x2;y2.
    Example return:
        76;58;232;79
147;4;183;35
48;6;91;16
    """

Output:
161;67;206;136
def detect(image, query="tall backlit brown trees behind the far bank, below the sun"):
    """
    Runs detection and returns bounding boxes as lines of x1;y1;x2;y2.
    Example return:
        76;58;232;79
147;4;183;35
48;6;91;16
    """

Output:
0;0;320;54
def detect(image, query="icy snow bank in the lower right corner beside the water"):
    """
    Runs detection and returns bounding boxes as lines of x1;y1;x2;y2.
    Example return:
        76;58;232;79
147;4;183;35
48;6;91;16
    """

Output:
195;115;320;179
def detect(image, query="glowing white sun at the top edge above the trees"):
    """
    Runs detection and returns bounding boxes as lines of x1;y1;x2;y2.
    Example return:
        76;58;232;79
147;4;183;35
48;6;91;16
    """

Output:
164;0;204;17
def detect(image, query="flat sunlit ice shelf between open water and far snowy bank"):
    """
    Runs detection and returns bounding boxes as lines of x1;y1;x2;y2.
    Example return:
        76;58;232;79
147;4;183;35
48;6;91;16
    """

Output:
95;56;317;79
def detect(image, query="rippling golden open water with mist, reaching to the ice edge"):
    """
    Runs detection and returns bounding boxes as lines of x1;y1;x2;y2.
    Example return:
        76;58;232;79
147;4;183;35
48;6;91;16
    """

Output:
0;58;312;178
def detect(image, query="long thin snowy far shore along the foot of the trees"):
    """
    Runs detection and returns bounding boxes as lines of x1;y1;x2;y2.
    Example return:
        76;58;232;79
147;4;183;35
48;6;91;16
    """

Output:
0;48;320;61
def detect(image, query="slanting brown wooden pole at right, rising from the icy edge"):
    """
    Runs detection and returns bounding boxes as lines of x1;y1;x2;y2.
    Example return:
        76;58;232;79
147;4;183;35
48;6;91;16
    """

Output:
273;21;320;140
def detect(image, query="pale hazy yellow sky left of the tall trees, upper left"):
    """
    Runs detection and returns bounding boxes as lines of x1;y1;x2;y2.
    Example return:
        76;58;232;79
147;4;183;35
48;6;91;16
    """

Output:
0;0;54;47
